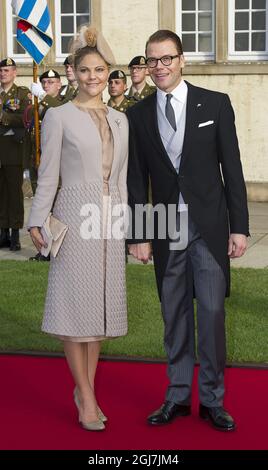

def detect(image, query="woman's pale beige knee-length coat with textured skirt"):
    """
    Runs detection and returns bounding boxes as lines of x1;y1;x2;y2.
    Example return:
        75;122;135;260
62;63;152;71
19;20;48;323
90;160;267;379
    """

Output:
28;102;128;338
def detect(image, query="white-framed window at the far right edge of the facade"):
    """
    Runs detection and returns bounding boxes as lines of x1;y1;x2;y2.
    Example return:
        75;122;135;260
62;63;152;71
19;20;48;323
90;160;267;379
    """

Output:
229;0;268;60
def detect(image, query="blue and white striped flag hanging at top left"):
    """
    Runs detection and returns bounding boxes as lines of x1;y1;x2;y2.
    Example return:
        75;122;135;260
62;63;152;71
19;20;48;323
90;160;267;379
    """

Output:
12;0;53;64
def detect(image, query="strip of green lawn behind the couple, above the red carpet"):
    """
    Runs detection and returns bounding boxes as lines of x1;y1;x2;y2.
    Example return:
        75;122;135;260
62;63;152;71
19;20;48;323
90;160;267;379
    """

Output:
0;261;268;363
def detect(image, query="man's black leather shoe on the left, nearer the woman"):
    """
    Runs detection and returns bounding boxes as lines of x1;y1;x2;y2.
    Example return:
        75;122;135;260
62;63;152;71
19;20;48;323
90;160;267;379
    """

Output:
147;401;191;426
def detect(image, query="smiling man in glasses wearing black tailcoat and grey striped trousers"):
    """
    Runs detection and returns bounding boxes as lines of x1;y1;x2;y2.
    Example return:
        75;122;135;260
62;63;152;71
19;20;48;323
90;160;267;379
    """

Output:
127;30;249;431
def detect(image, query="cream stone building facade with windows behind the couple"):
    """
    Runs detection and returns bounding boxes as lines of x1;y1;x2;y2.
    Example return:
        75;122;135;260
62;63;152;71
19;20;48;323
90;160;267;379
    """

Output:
0;0;268;201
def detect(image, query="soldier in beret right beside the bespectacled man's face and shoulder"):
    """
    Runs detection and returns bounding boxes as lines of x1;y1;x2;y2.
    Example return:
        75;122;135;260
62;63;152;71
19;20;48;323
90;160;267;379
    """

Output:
128;55;155;101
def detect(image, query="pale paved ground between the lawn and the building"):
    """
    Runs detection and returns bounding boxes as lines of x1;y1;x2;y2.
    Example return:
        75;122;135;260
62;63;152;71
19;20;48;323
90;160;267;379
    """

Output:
0;198;268;268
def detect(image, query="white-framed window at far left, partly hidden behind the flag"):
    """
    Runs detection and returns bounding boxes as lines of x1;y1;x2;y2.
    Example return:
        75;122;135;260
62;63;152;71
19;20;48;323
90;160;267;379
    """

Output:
6;0;31;62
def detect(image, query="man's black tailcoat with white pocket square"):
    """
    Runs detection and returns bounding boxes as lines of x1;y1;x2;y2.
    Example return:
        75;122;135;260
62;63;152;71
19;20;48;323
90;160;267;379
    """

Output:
127;82;249;297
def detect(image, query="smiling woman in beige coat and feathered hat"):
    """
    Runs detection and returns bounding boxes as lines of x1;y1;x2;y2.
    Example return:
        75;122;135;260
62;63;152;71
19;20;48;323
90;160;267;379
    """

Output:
28;27;128;431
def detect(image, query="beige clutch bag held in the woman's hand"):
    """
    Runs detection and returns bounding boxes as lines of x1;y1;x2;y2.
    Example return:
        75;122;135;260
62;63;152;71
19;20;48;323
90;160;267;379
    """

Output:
41;213;68;258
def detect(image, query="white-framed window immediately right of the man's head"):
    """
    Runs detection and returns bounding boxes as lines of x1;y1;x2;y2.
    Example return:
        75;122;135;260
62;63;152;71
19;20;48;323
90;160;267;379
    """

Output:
176;0;215;60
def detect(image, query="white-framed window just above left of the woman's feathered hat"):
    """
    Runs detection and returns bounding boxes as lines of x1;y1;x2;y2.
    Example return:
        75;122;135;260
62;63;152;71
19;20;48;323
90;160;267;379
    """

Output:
55;0;91;61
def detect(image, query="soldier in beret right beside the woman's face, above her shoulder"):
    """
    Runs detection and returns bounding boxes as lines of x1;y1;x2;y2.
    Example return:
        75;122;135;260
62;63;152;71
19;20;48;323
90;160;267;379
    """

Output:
107;70;136;113
